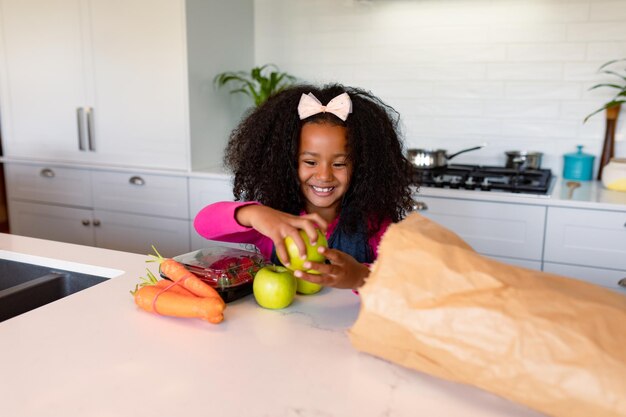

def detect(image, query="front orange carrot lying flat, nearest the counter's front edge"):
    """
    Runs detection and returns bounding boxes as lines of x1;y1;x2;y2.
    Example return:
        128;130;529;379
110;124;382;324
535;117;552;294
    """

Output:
135;285;225;324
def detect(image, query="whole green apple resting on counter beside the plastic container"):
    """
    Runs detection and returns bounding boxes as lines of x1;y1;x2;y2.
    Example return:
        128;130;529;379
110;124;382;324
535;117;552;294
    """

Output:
252;265;297;310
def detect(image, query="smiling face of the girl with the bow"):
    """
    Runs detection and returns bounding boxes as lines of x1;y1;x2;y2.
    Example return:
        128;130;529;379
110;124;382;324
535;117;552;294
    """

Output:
298;123;352;222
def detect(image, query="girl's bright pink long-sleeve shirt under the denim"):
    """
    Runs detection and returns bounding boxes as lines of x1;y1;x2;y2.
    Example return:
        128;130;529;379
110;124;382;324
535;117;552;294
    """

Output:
194;201;391;259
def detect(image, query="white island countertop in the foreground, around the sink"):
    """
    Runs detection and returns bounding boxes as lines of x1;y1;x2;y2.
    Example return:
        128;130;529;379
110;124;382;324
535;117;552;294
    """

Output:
0;234;540;417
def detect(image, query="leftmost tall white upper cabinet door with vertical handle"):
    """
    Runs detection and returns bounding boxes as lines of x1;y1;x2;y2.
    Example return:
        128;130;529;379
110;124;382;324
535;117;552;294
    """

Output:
0;0;87;160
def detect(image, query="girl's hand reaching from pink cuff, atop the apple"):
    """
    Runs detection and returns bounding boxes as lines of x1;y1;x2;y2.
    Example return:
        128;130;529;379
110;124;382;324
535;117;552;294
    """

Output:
235;204;328;259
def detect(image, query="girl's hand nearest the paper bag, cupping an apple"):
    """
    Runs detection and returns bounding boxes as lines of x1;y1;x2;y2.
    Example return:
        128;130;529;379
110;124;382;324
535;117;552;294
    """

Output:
294;247;370;290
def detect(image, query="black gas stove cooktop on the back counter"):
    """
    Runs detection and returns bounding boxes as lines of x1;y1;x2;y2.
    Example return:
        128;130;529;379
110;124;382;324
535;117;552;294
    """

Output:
413;165;552;196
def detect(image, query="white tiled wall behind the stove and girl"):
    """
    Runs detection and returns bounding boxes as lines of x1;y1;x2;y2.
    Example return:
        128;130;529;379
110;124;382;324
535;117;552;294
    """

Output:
255;0;626;175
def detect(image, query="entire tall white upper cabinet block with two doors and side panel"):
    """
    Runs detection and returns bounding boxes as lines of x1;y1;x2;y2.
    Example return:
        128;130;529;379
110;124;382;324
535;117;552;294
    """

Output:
0;0;253;171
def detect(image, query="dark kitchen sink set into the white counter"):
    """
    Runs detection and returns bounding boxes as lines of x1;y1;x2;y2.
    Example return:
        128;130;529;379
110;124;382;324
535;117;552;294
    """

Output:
0;259;108;321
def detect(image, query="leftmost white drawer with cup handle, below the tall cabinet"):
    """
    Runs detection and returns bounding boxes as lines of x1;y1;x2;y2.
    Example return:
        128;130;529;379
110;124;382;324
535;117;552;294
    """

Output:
4;163;92;207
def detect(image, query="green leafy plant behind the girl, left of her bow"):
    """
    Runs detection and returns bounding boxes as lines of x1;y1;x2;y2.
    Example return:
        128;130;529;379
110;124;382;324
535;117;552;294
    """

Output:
213;64;296;107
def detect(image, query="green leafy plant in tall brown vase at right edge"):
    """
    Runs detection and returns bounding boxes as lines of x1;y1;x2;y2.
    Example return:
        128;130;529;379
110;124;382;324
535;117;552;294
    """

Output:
583;58;626;180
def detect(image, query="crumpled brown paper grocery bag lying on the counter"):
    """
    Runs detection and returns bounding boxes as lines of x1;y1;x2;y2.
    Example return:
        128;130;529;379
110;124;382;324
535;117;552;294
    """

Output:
350;213;626;417
